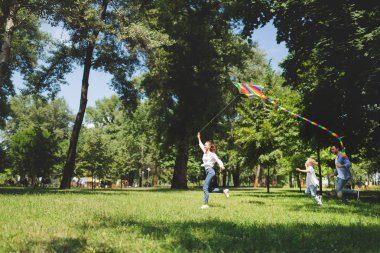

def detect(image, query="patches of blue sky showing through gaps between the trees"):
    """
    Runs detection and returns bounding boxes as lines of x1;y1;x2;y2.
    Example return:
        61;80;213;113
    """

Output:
13;23;288;113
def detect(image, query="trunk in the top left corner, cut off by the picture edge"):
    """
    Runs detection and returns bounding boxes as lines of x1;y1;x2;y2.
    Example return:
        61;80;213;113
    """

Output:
0;0;16;86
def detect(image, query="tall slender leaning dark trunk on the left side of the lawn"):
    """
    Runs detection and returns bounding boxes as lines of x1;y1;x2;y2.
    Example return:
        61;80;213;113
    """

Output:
60;0;109;189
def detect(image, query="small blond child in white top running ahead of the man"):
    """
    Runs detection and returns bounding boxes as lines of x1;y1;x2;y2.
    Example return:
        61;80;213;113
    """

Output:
296;158;322;206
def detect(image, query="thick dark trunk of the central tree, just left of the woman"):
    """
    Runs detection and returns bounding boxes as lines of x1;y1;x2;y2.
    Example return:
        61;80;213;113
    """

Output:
172;135;189;189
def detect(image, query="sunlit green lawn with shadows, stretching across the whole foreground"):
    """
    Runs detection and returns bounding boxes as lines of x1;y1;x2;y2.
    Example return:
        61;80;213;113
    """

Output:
0;188;380;252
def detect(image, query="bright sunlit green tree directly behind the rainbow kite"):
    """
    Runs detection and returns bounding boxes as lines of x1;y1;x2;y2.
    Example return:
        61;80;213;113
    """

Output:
227;61;308;186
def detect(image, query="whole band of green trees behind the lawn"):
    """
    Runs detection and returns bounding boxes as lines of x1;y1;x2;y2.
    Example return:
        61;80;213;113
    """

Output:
0;0;380;188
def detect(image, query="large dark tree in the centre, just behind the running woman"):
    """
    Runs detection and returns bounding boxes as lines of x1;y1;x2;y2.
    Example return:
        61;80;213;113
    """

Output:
144;1;272;188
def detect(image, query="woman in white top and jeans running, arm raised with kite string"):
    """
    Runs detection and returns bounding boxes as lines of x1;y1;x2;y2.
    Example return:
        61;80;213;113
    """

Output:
197;133;230;209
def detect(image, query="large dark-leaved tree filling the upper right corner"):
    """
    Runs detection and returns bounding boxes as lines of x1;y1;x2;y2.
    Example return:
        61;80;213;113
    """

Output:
274;0;380;162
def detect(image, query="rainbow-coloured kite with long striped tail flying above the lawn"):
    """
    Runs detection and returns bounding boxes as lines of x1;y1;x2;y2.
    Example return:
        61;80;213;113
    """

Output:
235;83;347;157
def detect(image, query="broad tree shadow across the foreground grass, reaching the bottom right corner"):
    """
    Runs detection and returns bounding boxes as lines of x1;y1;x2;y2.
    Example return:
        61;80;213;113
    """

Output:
78;215;380;252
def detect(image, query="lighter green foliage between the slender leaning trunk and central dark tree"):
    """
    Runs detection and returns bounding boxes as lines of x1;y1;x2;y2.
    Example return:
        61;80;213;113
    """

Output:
83;96;166;183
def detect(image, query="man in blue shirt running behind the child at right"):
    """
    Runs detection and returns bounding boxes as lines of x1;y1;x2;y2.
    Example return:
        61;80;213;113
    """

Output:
330;145;359;200
